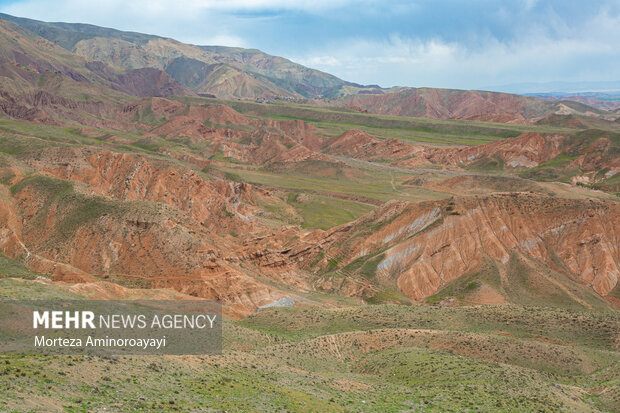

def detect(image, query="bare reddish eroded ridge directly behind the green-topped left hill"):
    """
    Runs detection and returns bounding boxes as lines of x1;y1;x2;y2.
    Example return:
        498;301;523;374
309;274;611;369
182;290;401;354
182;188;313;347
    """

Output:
19;148;268;233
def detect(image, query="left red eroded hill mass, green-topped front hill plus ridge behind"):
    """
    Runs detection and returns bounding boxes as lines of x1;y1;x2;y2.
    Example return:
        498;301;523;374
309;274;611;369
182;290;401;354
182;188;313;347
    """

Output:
0;148;308;316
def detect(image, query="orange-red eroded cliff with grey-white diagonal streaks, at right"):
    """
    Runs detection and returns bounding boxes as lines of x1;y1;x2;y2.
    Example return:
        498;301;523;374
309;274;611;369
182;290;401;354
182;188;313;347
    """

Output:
288;193;620;300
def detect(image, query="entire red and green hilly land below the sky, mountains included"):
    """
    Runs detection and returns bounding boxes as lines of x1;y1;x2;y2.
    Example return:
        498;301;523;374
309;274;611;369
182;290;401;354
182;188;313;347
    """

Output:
0;15;620;411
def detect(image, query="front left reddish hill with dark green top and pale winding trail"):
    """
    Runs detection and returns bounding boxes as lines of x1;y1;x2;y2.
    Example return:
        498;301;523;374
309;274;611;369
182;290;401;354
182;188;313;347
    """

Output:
0;171;298;316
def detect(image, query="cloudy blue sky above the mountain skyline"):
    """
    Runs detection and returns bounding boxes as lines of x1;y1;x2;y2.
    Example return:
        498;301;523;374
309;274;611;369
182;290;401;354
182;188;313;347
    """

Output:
0;0;620;90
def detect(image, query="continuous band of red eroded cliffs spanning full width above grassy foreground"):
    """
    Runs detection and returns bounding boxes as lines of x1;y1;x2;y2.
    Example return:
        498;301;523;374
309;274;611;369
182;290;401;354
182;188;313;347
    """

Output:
0;148;620;316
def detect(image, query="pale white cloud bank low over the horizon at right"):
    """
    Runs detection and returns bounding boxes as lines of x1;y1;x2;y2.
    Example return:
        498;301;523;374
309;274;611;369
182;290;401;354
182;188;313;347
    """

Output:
293;7;620;88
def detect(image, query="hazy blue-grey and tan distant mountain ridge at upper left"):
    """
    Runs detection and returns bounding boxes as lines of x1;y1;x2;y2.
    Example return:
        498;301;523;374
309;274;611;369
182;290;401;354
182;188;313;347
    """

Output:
0;13;352;98
